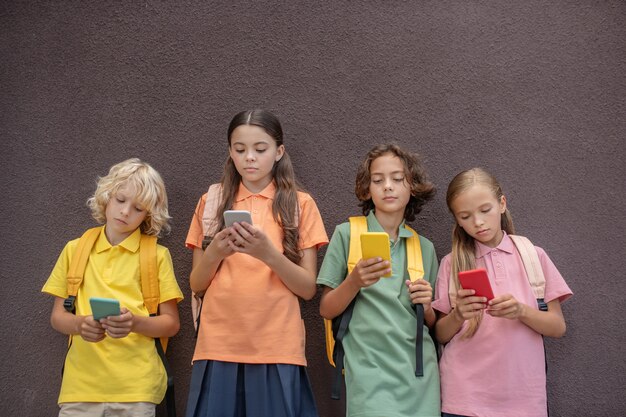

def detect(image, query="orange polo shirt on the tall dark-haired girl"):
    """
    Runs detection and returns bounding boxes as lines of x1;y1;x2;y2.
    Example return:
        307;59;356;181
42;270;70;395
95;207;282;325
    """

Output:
185;183;328;365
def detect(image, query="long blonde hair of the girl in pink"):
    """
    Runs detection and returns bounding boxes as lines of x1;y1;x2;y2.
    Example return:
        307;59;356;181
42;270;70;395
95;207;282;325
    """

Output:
446;168;515;338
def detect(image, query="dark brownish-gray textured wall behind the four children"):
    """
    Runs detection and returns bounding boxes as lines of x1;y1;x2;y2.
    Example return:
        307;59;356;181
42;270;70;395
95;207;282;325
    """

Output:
0;1;626;416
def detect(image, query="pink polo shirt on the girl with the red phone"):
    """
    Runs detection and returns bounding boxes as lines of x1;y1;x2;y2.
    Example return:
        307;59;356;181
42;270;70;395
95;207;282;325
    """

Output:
433;234;572;417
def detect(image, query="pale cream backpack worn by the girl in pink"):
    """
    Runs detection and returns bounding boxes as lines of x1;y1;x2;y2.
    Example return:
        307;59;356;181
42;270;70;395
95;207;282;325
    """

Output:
448;235;548;311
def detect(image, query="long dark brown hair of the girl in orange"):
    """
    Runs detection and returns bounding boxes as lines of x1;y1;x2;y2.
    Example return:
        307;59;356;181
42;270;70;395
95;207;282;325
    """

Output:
215;109;302;263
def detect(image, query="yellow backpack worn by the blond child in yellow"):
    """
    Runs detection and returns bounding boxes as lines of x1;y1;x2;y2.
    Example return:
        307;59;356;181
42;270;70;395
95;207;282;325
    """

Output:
63;226;176;417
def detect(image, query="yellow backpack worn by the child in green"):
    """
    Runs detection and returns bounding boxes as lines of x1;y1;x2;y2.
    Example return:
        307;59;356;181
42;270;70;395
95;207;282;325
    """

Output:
324;216;424;400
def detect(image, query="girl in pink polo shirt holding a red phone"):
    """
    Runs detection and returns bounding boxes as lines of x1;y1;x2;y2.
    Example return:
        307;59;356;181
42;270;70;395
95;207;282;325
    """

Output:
433;168;572;417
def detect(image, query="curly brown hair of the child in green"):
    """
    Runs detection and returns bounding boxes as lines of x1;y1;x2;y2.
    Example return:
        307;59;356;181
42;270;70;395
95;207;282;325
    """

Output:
354;143;436;222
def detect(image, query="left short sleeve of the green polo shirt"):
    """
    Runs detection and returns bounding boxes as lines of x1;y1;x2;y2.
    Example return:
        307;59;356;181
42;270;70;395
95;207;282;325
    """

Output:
317;223;350;288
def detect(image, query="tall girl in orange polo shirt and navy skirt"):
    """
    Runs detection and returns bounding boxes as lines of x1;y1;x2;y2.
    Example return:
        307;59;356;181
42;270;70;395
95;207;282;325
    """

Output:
186;110;328;417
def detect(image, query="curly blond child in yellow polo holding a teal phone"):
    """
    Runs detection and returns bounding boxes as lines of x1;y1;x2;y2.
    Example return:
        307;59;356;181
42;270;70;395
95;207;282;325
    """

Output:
42;159;183;416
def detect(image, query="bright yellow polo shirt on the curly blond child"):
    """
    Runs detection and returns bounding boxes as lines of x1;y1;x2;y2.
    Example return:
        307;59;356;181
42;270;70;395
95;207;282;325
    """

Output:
42;230;183;404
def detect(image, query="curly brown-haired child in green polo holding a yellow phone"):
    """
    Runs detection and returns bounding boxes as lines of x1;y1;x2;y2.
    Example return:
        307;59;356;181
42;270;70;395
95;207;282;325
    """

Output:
317;144;440;417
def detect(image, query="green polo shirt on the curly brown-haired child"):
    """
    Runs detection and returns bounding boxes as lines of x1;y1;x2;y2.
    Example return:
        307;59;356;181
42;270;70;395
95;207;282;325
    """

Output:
317;212;441;417
